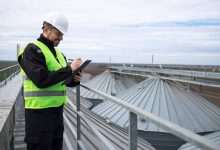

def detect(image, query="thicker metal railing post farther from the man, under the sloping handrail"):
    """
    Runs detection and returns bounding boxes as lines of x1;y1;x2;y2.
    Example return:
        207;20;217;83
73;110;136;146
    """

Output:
128;112;137;150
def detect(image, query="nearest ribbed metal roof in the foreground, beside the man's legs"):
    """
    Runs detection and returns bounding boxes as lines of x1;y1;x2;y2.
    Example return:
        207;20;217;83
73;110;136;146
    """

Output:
64;99;155;150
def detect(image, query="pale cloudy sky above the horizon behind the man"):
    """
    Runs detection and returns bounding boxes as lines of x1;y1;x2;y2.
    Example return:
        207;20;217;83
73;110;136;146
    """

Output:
0;0;220;65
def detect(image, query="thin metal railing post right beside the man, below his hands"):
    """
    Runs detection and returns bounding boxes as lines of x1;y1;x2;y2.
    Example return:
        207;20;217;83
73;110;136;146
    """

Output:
76;85;80;150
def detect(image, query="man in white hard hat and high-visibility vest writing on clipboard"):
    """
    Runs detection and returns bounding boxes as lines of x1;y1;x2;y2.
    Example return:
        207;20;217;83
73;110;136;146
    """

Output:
18;14;81;150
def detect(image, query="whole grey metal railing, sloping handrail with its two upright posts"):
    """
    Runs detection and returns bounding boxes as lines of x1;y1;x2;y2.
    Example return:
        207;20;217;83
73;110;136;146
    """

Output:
76;84;219;150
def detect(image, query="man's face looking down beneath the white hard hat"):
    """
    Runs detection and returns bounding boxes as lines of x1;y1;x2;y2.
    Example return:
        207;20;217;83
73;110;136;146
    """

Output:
47;28;63;47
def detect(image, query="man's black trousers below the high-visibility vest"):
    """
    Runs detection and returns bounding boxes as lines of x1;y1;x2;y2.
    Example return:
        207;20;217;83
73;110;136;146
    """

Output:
25;106;64;150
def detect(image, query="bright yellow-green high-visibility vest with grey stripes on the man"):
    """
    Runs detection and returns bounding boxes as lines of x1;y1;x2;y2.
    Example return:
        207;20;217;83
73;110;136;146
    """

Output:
18;41;67;109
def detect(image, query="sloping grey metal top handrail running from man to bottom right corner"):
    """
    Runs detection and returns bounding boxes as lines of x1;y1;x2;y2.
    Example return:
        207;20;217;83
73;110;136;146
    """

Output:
80;84;219;150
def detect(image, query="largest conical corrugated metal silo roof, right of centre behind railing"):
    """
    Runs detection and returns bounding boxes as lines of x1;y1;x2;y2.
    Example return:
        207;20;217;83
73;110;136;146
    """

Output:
93;78;220;132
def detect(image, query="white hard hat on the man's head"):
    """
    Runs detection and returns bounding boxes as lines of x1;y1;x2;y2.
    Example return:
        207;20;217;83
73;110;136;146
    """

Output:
44;13;69;34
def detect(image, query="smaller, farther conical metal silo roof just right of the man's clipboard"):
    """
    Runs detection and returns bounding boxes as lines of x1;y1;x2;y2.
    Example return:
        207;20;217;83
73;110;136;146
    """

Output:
80;70;126;99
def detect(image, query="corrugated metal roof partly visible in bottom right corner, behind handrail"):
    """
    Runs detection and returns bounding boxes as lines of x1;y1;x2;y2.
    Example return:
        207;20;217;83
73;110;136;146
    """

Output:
178;131;220;150
